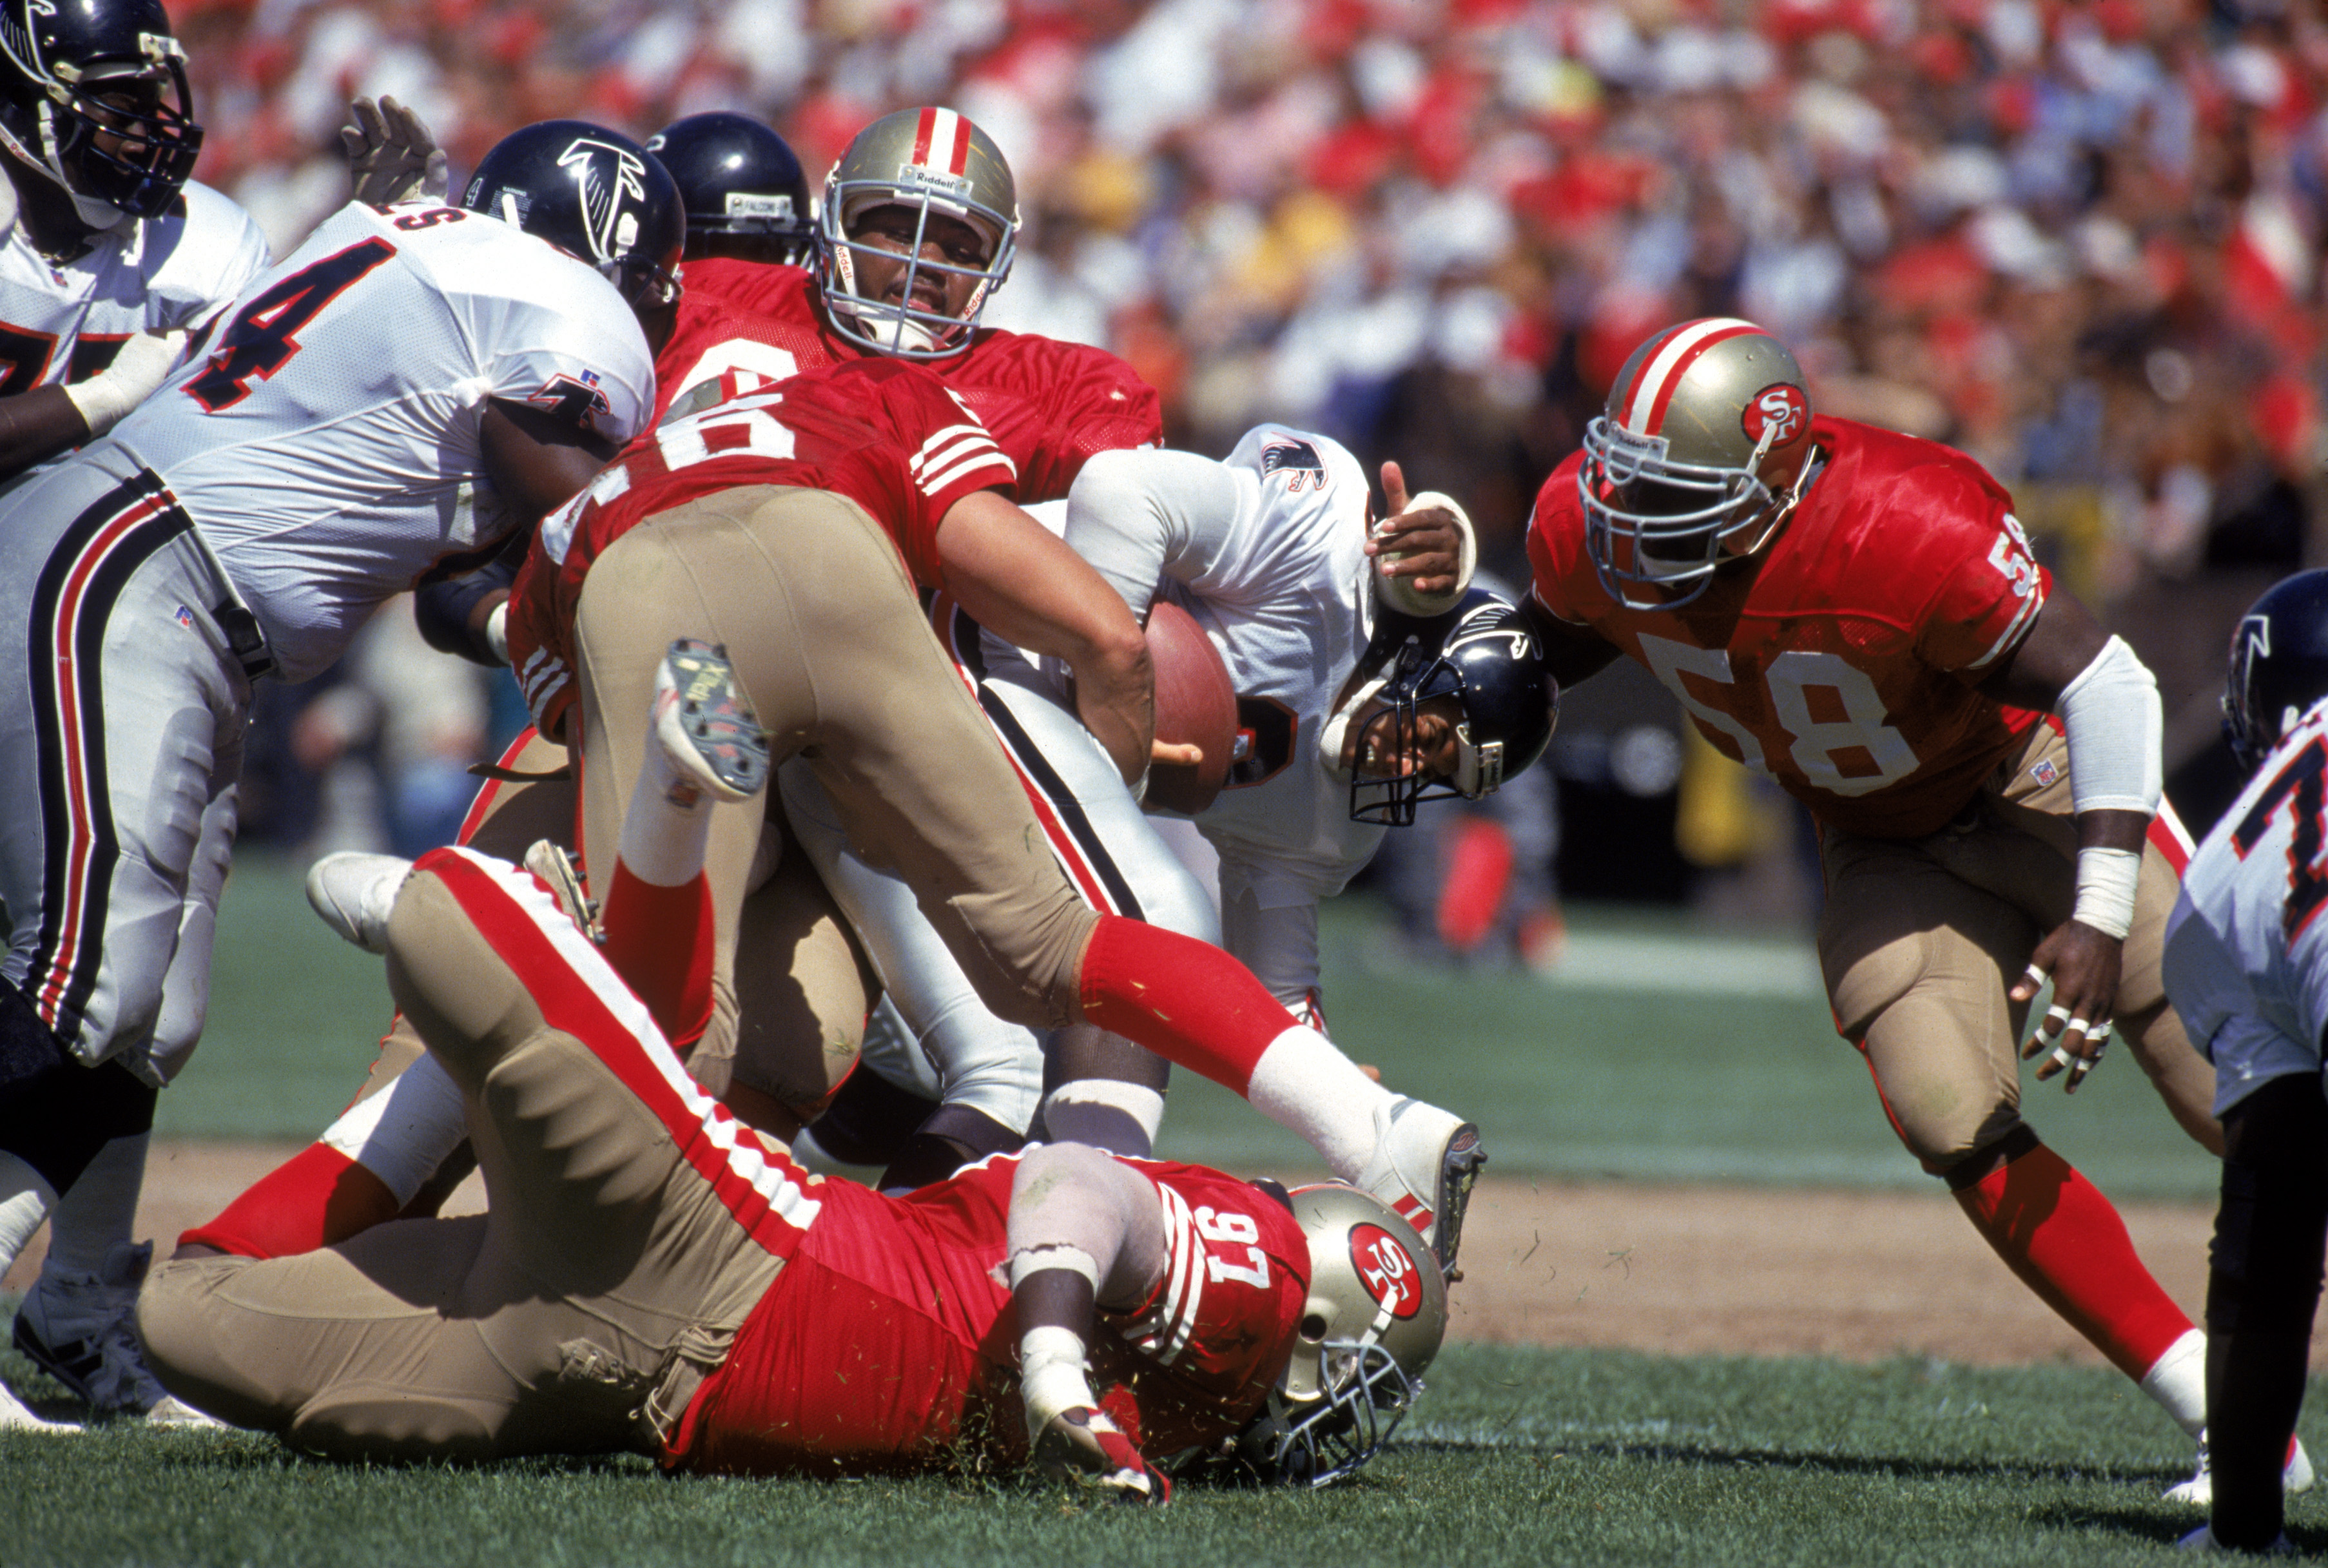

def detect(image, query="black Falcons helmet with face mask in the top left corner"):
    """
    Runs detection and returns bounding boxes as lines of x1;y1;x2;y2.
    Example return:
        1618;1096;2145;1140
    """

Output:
0;0;202;228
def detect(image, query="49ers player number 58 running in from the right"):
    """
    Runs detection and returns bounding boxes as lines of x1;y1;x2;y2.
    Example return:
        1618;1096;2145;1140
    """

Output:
1527;319;2309;1505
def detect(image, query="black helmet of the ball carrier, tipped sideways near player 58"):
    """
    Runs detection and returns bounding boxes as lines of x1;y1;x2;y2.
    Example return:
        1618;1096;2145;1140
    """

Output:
1350;588;1560;828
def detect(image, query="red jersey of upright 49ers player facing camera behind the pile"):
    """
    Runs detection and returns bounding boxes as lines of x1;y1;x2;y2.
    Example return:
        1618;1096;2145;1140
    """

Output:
654;256;1164;503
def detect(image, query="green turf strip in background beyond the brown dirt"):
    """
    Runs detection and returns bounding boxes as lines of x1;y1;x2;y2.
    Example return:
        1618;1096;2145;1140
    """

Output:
159;856;2214;1198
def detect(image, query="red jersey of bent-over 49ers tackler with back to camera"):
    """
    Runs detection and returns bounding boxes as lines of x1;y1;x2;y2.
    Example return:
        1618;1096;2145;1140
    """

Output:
510;358;1015;737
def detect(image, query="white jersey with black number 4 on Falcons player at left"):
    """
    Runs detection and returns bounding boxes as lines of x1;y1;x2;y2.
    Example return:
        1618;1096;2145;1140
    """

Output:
100;202;654;682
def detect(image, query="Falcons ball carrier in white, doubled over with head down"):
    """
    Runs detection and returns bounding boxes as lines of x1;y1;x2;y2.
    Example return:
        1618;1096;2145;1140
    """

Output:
777;426;1553;1256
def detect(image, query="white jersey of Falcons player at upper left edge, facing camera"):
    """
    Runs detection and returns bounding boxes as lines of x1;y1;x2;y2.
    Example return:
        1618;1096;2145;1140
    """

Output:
0;175;267;398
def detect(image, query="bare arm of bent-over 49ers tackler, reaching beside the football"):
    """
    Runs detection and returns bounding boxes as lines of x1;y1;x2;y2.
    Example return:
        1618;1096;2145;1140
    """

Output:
938;491;1157;784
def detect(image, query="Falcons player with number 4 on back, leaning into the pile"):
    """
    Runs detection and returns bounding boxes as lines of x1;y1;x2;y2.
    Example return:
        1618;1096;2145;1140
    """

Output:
0;121;680;1410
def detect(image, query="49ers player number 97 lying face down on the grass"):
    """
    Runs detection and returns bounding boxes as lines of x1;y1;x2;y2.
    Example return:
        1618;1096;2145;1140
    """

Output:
140;644;1446;1503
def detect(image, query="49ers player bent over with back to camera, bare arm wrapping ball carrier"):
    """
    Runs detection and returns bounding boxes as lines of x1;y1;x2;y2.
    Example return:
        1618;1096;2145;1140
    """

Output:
214;361;1479;1302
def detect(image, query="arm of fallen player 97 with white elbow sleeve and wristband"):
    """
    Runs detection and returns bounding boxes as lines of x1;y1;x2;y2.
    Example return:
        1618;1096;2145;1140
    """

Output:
1011;1142;1171;1503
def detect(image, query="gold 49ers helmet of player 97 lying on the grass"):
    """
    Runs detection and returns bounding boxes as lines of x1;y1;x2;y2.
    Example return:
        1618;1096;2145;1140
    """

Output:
1236;1182;1448;1487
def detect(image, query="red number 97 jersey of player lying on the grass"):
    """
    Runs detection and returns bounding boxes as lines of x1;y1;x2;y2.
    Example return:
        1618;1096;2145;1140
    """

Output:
663;1156;1308;1475
